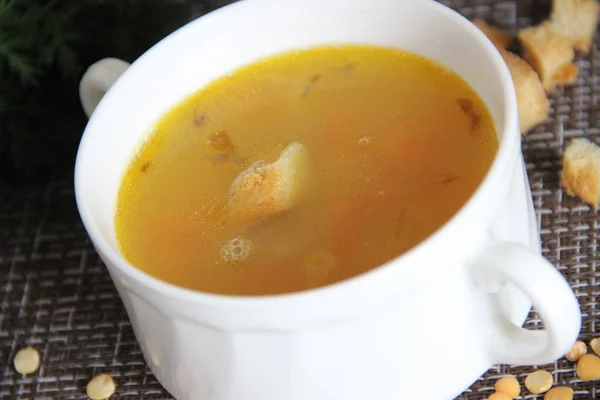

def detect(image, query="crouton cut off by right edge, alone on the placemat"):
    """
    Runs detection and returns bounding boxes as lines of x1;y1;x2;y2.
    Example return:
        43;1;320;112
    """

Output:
561;138;600;207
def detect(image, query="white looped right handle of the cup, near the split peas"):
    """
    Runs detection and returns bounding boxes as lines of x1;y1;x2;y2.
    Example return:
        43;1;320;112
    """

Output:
472;242;581;365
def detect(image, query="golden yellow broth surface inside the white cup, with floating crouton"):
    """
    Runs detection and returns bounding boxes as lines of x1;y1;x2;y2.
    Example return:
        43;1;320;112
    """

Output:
116;46;498;295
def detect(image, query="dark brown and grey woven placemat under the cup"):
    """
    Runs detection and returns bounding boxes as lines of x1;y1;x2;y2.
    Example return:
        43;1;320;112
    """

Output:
0;0;600;400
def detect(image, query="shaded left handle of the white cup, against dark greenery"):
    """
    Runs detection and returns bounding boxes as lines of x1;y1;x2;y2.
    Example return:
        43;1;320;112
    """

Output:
79;58;129;118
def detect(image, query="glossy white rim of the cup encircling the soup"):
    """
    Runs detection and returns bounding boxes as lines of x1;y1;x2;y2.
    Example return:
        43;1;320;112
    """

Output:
74;0;520;309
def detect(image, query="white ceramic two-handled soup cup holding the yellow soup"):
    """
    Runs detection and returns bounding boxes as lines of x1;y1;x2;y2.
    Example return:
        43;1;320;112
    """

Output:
75;0;580;400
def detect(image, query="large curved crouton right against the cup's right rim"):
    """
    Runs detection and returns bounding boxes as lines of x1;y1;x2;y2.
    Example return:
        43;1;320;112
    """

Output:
500;50;550;134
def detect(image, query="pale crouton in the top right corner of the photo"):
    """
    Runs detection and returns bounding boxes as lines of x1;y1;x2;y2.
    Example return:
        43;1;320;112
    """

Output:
550;0;600;54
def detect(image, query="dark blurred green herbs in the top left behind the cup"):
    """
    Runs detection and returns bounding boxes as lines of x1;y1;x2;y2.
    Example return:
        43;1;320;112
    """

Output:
0;0;195;181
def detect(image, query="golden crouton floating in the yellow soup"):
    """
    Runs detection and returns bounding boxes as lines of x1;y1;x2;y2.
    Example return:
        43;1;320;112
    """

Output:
228;142;308;224
